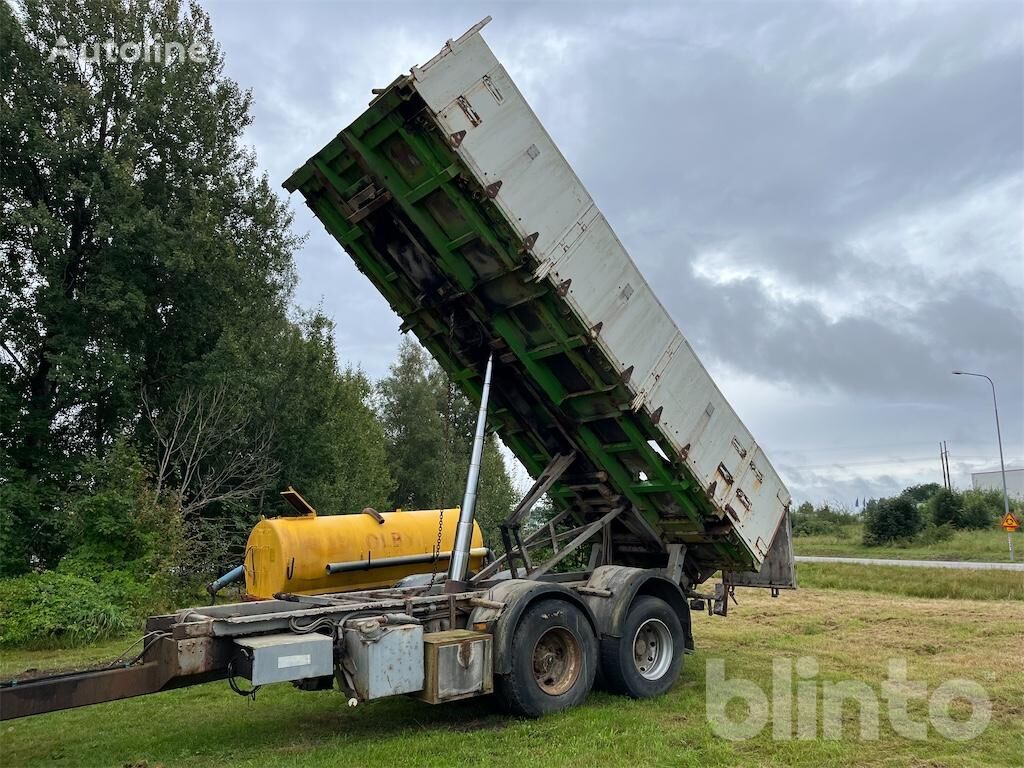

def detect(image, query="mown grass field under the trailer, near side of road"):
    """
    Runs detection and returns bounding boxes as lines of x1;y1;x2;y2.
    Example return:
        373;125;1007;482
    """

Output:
0;565;1024;768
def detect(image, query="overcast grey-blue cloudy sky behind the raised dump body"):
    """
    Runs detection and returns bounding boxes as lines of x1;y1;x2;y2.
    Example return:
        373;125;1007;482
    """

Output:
201;0;1024;506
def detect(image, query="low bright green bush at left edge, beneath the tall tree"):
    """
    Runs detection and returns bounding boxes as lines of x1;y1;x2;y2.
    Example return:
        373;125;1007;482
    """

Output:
0;570;147;647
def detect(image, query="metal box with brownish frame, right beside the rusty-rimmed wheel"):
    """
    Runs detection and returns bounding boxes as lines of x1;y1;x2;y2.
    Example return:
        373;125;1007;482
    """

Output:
419;630;495;703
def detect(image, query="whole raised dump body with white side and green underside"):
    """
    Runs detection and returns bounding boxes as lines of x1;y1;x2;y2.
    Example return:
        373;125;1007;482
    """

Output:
285;19;790;582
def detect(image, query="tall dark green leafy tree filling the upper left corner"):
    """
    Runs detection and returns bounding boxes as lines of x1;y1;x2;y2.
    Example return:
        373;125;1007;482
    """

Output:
0;0;298;572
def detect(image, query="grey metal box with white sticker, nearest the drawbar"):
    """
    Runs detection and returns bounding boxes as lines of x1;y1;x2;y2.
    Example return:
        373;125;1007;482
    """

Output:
234;633;334;685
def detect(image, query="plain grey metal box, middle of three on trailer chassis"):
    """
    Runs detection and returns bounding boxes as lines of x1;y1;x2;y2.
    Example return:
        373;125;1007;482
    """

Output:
345;624;423;700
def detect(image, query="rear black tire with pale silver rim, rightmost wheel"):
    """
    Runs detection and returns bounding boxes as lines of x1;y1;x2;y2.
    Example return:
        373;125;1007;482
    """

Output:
601;595;685;698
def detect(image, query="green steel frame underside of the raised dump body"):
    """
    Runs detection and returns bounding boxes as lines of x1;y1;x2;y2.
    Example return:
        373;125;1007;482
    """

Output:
285;78;753;581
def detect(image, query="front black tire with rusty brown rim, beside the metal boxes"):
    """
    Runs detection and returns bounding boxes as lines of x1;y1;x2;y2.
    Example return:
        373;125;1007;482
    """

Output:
495;598;598;718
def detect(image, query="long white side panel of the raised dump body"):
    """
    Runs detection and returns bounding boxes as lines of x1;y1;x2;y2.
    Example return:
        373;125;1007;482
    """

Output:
413;26;790;564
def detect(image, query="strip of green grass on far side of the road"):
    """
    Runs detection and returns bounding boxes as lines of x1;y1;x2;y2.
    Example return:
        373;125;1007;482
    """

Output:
793;523;1024;562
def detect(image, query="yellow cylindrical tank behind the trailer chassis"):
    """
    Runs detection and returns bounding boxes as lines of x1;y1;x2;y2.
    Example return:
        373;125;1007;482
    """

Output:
244;507;486;600
